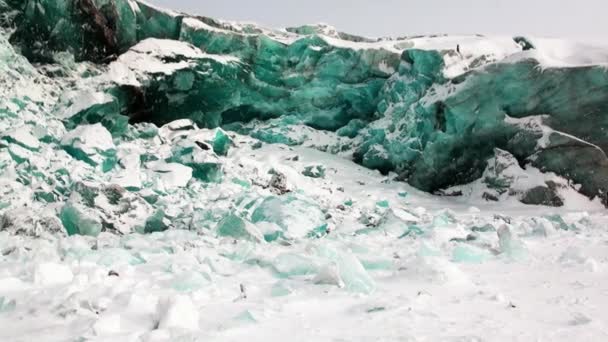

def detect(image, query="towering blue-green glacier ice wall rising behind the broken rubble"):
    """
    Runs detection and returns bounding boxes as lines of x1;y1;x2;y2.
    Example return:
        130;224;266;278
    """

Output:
4;0;608;203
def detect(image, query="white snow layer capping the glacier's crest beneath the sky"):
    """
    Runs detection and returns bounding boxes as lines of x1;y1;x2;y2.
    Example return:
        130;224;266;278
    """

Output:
144;0;608;78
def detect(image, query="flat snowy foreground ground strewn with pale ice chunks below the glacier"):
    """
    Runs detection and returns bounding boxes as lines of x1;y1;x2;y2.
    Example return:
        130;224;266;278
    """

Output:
0;140;608;341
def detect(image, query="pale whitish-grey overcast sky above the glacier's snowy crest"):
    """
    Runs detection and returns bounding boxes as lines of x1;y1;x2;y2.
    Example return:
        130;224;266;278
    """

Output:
147;0;608;45
